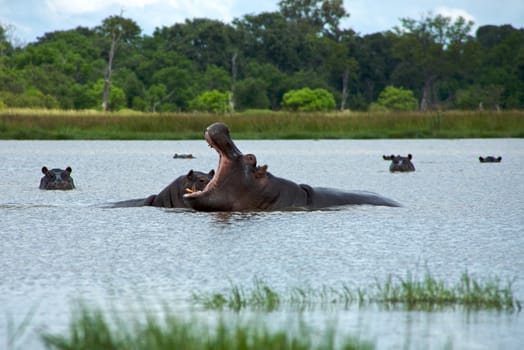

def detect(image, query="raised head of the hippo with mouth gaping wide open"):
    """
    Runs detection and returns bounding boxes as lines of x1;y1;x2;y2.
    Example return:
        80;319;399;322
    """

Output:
184;123;267;211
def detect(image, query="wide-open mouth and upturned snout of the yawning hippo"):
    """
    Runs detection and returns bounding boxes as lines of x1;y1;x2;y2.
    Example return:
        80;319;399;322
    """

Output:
184;123;243;198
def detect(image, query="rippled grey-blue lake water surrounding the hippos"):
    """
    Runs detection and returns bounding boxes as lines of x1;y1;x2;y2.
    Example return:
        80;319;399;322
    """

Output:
0;138;524;349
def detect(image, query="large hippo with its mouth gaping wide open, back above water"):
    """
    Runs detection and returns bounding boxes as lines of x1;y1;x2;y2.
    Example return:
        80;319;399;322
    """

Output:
183;123;399;211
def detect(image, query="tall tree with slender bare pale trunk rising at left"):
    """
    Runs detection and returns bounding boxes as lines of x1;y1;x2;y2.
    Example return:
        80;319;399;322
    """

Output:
97;15;142;111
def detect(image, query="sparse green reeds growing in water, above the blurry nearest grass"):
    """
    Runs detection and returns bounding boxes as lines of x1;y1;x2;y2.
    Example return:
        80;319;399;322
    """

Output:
193;272;521;311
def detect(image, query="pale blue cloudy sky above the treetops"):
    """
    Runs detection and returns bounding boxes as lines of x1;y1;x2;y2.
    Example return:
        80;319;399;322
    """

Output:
0;0;524;46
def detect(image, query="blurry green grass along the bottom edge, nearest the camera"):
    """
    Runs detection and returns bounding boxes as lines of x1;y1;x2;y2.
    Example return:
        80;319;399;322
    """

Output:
42;307;374;350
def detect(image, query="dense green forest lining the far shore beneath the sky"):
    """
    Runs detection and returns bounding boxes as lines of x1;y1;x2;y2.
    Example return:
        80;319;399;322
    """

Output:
0;0;524;112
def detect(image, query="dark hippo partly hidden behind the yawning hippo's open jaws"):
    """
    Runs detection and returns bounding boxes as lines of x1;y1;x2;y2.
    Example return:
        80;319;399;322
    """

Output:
113;169;215;208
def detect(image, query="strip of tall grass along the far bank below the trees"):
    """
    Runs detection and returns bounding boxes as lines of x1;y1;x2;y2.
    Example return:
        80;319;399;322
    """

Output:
0;109;524;140
